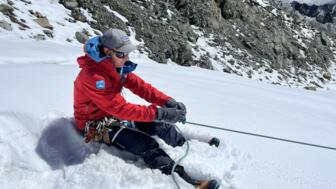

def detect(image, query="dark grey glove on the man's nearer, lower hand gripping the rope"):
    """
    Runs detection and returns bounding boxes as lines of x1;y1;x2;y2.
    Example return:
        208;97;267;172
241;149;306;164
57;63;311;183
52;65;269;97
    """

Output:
157;108;187;124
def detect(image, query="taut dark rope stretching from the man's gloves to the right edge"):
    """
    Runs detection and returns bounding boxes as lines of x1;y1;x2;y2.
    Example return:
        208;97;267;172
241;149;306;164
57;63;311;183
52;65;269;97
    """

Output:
186;121;336;151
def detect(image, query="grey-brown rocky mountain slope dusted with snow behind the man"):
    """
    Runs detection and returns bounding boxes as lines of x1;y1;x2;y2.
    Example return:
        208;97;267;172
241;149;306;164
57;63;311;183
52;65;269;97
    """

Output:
0;0;336;90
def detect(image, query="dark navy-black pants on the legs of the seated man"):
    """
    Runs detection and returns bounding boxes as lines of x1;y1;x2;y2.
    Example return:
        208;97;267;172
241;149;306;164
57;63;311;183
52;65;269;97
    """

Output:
105;122;186;174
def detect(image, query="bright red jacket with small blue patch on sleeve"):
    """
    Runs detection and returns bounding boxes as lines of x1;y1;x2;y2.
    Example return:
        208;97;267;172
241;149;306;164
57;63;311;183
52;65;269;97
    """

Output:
74;55;171;130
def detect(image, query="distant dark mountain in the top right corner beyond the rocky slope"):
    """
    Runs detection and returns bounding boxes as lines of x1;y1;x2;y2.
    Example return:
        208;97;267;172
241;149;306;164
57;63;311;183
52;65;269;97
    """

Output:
291;1;336;24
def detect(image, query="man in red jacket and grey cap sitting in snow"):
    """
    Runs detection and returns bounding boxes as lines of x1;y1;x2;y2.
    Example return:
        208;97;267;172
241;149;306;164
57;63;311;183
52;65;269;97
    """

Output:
74;29;219;188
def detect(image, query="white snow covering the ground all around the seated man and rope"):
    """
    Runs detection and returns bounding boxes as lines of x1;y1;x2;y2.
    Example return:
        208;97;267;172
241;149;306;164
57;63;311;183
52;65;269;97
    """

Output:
0;0;336;189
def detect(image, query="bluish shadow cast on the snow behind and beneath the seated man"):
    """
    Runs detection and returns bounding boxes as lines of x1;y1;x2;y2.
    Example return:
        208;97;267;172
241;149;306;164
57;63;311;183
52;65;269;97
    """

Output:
35;118;138;170
